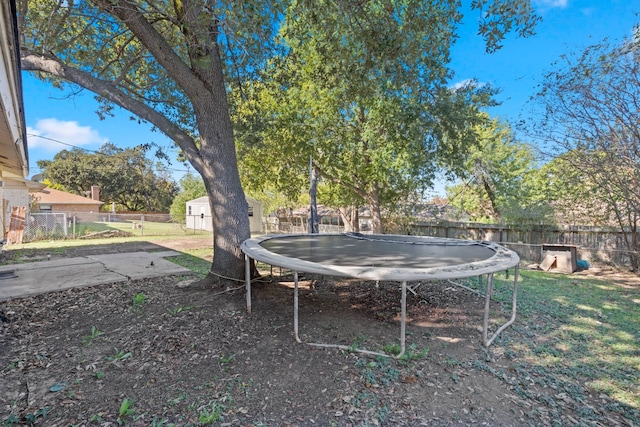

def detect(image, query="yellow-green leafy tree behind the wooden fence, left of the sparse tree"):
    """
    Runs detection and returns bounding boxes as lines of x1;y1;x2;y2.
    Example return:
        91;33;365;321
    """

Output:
446;113;548;223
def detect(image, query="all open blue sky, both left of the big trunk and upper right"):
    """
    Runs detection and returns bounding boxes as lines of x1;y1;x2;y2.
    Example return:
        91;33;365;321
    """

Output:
23;0;640;186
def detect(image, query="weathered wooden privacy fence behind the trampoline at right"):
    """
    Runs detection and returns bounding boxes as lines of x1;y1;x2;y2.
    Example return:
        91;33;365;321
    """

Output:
402;221;634;267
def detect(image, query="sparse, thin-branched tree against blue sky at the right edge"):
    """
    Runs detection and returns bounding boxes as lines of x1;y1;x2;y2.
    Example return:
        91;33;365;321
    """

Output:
529;28;640;271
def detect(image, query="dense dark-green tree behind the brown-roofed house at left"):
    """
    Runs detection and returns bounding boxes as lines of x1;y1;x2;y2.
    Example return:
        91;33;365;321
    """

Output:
38;143;178;212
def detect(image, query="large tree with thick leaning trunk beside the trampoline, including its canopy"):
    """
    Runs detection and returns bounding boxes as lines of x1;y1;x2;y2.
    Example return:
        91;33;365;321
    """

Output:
19;0;535;284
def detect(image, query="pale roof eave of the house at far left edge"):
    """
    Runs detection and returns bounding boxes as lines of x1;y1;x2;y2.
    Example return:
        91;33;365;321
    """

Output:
0;0;29;180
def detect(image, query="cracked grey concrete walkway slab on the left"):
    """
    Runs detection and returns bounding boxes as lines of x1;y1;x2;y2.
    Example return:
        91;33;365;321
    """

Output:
0;251;191;301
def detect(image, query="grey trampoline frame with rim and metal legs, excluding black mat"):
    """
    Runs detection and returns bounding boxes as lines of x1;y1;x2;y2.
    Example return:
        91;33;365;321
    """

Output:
241;233;519;359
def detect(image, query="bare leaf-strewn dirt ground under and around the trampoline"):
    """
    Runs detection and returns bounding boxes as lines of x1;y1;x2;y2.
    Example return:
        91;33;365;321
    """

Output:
0;242;628;426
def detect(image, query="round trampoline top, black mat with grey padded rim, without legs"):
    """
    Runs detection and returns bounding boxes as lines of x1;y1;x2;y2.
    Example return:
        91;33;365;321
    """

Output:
242;233;519;280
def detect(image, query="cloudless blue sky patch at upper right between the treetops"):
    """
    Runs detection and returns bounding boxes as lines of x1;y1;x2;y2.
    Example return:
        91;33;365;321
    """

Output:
451;0;640;125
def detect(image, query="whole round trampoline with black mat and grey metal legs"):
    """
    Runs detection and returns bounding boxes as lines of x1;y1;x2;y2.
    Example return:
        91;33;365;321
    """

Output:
241;233;520;358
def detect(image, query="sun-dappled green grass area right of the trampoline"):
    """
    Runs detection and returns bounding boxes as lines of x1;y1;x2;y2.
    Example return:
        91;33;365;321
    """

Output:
480;271;640;423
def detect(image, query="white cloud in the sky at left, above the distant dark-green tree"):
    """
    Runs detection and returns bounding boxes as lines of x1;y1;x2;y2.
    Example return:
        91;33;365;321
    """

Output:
27;118;109;152
